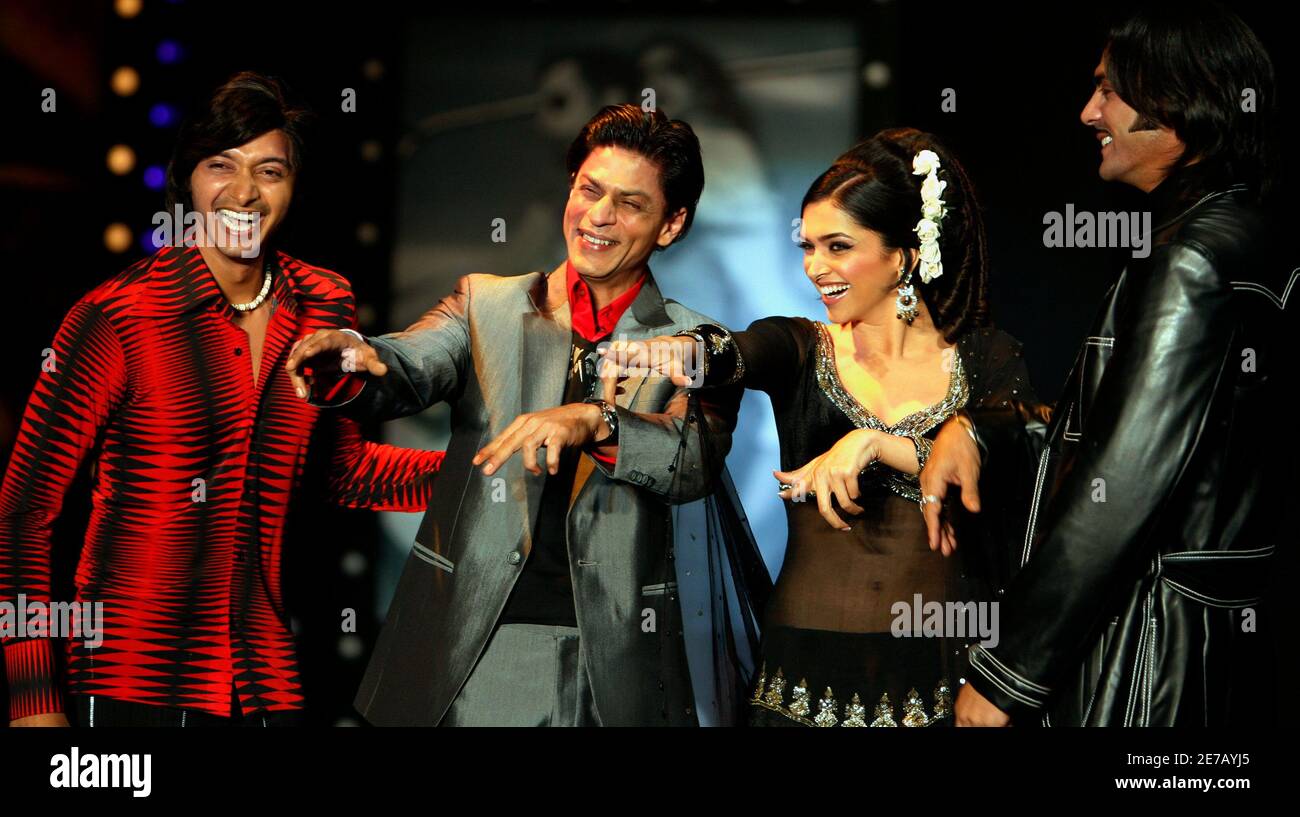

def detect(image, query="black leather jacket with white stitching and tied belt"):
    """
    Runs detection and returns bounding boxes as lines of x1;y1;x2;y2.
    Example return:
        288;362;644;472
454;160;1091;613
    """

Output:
969;185;1300;725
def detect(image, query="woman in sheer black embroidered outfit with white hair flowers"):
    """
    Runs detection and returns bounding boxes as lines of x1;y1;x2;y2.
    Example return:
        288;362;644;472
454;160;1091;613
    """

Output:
606;129;1030;726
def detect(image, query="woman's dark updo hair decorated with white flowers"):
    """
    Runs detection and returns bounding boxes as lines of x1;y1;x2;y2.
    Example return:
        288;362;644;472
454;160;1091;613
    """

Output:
800;127;989;343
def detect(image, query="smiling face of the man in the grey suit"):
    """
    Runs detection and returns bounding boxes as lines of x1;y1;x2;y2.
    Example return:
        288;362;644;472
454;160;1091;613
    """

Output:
564;146;686;284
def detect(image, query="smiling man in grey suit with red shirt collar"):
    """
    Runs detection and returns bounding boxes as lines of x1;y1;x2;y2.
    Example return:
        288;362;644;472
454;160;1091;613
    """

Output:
287;105;740;726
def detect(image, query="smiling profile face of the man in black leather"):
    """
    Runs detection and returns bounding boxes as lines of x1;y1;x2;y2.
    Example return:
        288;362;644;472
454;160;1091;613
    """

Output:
1079;53;1183;193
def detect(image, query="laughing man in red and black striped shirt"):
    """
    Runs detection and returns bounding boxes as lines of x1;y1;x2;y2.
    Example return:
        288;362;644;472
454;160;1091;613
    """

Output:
0;74;443;726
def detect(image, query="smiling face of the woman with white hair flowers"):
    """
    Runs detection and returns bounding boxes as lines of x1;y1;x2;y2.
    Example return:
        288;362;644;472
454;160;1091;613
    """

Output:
800;199;907;324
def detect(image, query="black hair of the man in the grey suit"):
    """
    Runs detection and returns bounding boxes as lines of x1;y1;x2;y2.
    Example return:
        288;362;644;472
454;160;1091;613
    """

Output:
566;103;705;250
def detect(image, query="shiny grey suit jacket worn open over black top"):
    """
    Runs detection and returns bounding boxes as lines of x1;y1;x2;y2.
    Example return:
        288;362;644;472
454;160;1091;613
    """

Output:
348;267;741;726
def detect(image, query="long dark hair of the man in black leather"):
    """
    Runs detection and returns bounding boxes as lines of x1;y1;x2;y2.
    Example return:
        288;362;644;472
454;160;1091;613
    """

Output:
1105;0;1277;195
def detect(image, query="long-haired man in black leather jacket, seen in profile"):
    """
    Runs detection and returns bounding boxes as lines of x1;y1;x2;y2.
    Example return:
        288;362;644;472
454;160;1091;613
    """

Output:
922;7;1300;726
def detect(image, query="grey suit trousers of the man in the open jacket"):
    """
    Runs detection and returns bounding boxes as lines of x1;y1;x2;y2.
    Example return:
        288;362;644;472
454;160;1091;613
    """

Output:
439;624;601;726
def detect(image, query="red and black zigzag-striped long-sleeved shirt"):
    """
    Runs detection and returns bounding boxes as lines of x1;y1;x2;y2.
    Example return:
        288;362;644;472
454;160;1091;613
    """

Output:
0;247;443;718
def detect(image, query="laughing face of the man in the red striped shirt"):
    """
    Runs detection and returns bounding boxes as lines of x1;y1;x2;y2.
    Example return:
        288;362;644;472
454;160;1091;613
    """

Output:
190;130;294;259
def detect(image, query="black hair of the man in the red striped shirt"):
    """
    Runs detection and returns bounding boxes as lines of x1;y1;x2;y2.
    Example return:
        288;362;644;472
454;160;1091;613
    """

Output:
166;72;315;211
